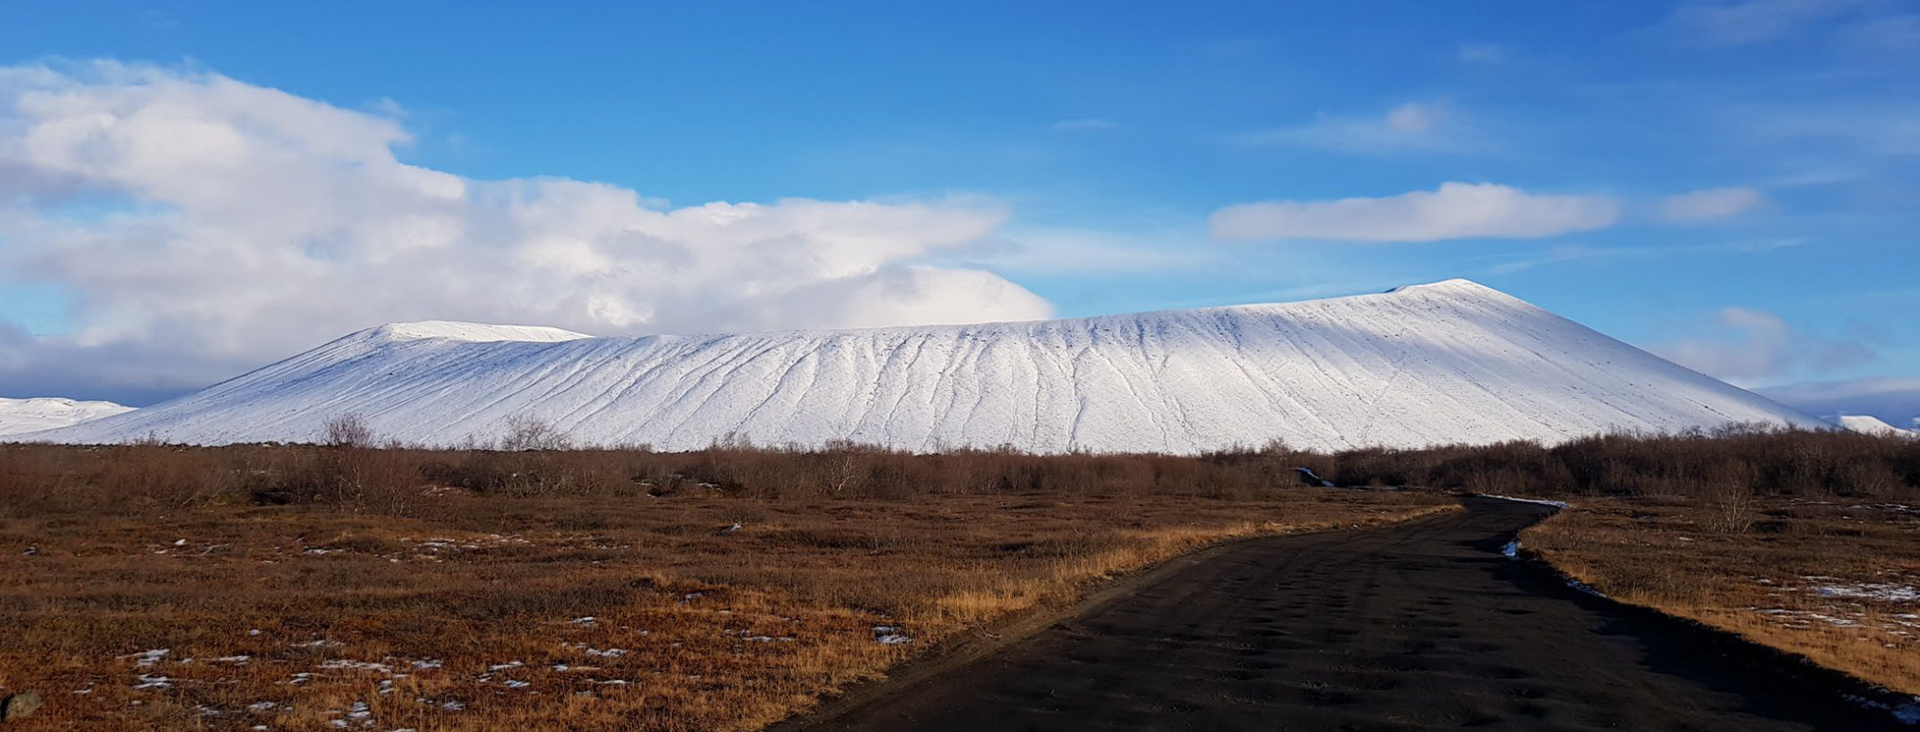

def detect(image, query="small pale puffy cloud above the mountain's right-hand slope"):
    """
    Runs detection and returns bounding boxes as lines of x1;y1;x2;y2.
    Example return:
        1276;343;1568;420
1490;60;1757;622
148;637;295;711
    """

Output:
1649;307;1874;382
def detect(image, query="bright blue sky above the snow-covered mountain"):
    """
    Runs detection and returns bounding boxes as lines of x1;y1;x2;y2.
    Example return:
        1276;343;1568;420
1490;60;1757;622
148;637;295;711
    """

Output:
0;0;1920;419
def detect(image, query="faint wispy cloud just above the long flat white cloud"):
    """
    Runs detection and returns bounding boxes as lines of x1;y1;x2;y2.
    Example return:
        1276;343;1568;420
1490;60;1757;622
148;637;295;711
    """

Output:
1235;100;1480;152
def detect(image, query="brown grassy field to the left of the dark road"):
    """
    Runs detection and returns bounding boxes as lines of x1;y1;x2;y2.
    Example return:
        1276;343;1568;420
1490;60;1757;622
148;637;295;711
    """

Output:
0;446;1452;732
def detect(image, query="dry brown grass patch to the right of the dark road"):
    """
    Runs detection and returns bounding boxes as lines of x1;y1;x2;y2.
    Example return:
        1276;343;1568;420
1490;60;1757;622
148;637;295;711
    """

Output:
1521;498;1920;694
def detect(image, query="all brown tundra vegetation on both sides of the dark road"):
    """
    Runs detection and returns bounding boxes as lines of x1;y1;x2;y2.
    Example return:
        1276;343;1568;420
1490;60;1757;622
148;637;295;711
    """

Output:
0;417;1920;730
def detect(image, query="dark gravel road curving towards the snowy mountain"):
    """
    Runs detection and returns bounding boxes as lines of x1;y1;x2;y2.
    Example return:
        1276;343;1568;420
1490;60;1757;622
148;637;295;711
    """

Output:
780;498;1910;732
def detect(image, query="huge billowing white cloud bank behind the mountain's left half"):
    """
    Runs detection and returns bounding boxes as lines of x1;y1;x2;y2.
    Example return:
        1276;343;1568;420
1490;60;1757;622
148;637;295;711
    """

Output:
0;63;1052;401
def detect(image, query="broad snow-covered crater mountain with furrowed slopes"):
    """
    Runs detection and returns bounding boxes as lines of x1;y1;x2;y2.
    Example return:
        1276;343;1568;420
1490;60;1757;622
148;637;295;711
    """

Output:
35;281;1824;453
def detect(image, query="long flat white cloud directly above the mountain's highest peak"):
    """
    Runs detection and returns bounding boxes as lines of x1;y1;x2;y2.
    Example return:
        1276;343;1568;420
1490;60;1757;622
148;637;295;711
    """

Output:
1210;183;1620;242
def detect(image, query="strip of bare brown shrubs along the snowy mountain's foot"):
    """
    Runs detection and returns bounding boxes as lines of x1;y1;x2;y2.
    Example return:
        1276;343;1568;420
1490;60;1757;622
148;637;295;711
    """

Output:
0;419;1920;515
